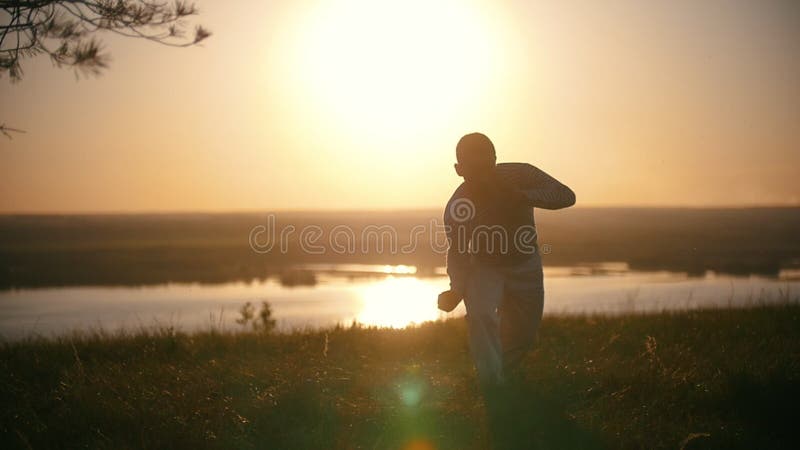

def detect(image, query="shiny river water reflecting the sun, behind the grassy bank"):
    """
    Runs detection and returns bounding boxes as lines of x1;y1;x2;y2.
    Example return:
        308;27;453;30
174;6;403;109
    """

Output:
0;264;800;339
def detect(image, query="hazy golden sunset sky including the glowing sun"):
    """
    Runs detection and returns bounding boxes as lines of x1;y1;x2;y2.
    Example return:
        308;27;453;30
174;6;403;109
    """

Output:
0;0;800;212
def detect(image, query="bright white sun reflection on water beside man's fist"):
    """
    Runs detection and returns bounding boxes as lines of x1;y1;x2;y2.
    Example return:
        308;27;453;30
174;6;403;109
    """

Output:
357;276;446;328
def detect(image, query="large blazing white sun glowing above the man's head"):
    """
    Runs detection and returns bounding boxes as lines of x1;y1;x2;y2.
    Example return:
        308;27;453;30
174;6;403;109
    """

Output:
284;0;502;137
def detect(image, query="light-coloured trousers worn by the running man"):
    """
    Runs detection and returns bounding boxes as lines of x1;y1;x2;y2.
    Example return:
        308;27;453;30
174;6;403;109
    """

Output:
464;253;544;385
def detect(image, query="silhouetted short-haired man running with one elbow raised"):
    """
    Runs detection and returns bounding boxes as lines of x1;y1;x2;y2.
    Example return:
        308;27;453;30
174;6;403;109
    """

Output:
439;133;575;387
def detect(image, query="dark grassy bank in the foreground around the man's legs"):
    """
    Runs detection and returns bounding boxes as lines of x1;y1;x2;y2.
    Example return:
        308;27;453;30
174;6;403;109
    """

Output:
0;303;800;449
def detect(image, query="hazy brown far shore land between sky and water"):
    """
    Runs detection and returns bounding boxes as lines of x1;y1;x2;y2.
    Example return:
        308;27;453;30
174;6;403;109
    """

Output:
0;208;800;289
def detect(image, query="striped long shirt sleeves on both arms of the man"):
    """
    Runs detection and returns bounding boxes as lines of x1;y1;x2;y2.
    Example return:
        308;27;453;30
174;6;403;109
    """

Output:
444;163;575;294
